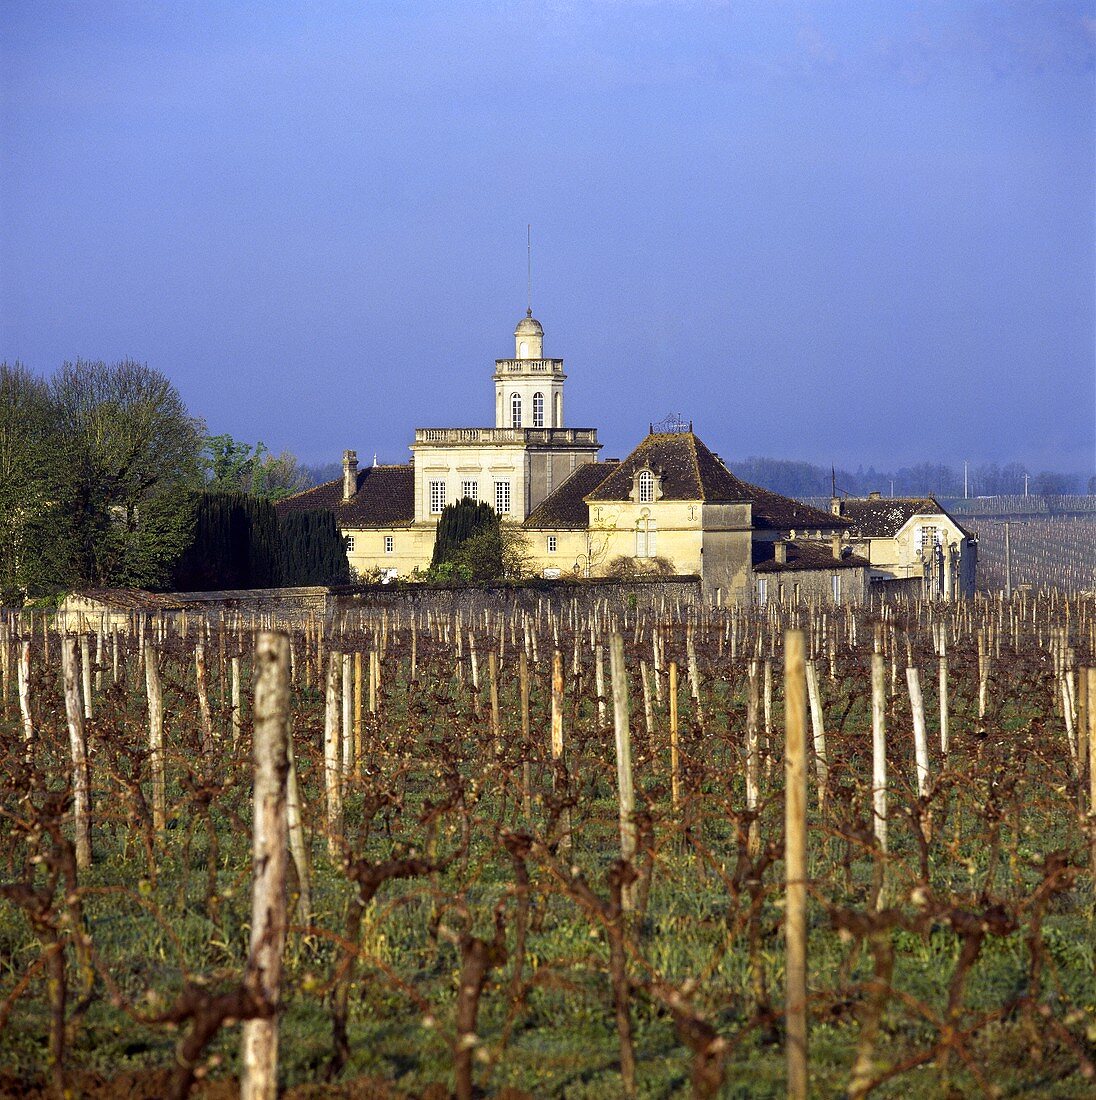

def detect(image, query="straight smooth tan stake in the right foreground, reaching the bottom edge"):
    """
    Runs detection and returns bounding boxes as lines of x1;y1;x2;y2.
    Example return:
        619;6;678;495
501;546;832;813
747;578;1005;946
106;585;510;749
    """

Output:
783;630;808;1100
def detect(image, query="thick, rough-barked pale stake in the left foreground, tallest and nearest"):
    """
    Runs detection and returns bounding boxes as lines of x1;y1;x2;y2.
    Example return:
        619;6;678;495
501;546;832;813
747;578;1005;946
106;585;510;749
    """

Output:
240;631;289;1100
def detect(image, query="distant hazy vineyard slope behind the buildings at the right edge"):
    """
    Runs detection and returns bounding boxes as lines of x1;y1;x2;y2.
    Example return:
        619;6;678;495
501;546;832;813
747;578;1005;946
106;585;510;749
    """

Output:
977;515;1096;592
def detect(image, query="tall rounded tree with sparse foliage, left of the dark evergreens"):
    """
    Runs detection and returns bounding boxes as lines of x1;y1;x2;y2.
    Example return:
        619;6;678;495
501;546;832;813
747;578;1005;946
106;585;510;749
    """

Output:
50;360;202;587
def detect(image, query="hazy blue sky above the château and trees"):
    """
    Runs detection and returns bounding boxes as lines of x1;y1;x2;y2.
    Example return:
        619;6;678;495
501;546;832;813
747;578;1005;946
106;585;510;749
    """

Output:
0;0;1096;473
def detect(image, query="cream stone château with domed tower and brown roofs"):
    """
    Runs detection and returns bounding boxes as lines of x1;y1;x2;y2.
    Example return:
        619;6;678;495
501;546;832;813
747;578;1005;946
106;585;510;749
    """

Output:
277;311;868;603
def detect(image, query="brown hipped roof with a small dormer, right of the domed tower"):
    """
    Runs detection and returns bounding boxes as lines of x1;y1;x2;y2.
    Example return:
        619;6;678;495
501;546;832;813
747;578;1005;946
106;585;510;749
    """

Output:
587;431;850;530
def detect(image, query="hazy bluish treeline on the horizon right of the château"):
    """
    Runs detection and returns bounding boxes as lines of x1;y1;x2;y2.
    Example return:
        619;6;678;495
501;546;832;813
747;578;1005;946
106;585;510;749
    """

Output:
727;458;1096;497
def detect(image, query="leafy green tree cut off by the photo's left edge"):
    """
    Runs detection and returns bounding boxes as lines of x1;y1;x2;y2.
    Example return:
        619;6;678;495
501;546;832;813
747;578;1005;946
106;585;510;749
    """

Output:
0;363;73;605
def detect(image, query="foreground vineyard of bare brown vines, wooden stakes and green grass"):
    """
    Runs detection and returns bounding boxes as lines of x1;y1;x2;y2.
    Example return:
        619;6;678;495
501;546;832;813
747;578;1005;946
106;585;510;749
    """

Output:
0;598;1096;1100
